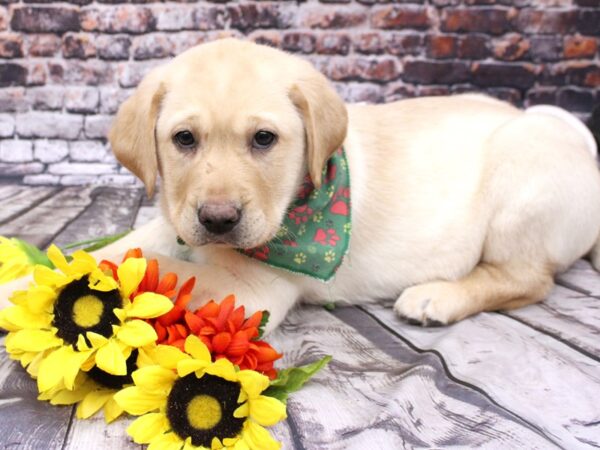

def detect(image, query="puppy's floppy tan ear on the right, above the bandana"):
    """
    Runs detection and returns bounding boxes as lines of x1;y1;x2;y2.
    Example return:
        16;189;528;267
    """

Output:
290;68;348;187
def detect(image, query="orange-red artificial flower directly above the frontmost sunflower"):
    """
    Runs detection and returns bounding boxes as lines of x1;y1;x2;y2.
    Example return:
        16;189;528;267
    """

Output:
150;295;282;379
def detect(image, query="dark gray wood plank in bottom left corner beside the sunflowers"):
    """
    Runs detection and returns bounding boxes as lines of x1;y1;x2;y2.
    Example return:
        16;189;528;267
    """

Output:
0;337;73;450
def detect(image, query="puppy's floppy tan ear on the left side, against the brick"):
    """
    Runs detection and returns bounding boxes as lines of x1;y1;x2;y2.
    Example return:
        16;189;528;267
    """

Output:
108;68;165;197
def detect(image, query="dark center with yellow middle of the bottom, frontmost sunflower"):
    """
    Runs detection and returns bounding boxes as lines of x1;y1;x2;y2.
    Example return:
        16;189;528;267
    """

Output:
167;373;245;448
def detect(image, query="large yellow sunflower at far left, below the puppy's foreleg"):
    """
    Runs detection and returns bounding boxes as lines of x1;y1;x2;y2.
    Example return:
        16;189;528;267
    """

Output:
0;245;173;393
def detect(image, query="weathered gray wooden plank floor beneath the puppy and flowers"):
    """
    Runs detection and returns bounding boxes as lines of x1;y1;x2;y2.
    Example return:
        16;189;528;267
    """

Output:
0;185;600;450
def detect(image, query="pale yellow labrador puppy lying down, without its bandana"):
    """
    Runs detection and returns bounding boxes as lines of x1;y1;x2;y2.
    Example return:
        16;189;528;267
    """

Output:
2;39;600;327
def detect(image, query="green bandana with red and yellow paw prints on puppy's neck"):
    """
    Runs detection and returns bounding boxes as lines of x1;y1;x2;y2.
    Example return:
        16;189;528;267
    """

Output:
239;149;351;281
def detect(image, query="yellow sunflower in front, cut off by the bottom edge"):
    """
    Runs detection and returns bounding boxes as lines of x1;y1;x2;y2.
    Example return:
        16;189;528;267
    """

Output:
115;335;286;450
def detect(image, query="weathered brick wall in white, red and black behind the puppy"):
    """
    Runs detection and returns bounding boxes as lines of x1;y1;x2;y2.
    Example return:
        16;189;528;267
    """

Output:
0;0;600;184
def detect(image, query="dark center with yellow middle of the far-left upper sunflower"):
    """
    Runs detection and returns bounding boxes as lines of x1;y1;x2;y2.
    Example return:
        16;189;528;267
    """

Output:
52;276;123;344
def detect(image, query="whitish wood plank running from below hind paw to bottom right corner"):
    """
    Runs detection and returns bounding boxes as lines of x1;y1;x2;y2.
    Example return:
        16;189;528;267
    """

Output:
364;305;600;448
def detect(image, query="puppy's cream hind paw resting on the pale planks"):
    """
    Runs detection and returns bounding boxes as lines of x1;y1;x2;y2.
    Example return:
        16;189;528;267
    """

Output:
394;281;469;327
